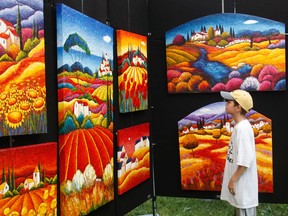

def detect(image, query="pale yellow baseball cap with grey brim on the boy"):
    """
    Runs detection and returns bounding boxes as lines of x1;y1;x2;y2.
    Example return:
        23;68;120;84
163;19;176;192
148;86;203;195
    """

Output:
220;89;253;112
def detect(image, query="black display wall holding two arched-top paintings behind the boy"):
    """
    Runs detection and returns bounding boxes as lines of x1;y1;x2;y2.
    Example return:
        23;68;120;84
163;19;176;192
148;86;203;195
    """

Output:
149;0;288;203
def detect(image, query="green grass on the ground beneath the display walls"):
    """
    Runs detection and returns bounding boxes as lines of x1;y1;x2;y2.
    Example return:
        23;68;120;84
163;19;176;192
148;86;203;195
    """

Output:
125;197;288;216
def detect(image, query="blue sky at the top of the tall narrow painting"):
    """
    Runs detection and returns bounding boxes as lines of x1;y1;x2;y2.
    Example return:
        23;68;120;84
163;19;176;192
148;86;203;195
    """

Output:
56;4;114;63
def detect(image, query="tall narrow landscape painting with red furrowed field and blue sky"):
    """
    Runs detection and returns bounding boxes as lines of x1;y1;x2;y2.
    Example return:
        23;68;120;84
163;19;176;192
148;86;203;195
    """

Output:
56;4;114;216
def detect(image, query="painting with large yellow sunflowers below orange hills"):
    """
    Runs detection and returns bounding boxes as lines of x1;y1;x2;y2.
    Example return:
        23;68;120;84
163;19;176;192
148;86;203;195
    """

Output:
0;0;47;137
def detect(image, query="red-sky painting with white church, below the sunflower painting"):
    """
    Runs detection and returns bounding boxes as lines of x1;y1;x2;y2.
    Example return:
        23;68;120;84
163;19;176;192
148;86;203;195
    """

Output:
0;142;58;216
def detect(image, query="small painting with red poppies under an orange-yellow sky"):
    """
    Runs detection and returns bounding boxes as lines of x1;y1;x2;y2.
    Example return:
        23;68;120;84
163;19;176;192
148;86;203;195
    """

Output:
116;30;148;113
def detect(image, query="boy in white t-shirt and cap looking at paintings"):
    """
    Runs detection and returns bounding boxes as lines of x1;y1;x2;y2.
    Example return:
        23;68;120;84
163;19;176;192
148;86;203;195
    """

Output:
220;90;258;216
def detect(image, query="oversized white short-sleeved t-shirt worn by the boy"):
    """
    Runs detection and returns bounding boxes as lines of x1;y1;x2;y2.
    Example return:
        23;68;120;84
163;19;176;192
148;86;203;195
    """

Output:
220;119;258;209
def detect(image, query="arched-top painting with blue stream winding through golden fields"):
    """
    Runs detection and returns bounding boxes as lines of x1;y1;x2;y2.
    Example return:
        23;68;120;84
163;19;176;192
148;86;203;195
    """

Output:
165;13;286;94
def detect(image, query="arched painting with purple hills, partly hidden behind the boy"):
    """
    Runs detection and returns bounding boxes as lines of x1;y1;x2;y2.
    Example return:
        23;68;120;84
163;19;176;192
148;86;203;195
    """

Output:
178;102;273;193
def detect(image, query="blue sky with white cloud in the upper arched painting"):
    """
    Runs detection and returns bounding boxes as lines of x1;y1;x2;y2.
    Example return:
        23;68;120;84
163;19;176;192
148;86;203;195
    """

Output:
165;13;285;45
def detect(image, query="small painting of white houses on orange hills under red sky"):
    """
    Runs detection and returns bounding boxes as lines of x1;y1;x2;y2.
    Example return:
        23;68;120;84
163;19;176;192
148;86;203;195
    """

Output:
117;123;150;195
